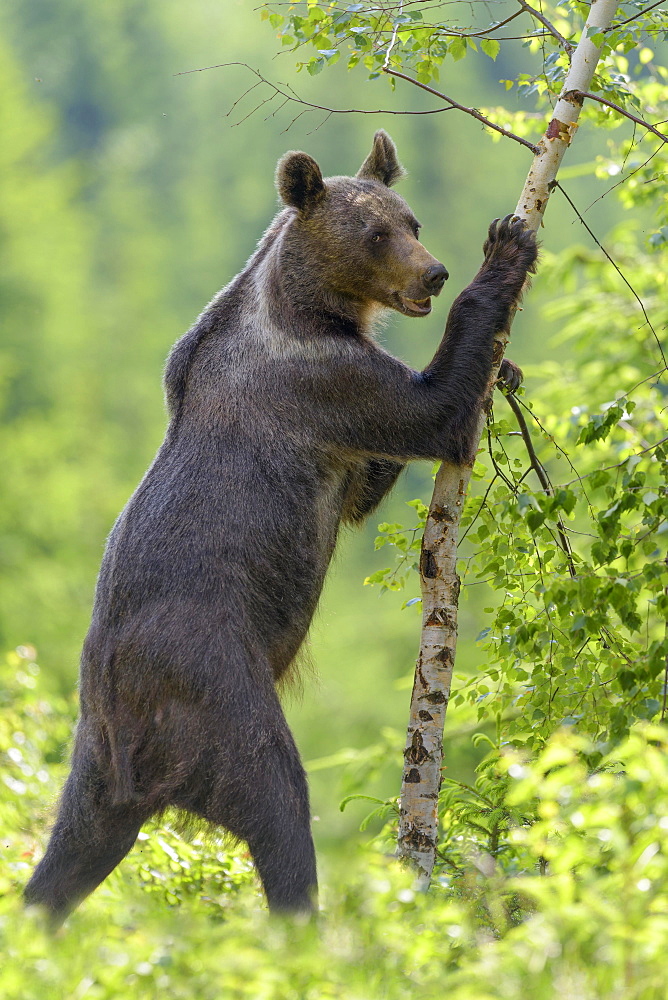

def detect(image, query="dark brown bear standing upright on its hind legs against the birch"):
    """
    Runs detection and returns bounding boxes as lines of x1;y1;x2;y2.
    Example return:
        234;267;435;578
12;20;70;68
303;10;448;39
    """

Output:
26;132;536;922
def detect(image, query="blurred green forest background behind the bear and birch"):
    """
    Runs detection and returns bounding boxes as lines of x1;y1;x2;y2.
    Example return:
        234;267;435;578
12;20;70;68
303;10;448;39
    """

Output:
0;0;628;848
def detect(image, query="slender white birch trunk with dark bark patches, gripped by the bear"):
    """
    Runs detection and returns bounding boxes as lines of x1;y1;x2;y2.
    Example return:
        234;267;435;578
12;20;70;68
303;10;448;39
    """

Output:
398;0;618;889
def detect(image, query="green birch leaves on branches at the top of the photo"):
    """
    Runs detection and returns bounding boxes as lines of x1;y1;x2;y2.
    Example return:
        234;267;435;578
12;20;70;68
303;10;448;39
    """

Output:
261;0;668;148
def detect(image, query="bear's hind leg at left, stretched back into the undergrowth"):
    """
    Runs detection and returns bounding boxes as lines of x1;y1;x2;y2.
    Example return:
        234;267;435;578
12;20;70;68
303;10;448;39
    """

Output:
24;739;149;928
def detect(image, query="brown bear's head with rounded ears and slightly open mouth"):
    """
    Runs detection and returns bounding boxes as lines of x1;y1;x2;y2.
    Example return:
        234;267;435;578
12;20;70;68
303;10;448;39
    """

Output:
276;131;448;316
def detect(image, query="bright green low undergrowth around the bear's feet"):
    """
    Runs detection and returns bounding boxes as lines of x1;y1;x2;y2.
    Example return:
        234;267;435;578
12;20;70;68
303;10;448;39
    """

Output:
0;649;668;1000
